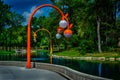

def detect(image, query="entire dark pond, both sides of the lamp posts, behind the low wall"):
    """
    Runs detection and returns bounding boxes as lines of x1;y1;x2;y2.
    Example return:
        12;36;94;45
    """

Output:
0;52;120;80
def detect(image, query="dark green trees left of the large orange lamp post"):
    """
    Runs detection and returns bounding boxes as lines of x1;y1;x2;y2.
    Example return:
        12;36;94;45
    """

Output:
0;1;25;50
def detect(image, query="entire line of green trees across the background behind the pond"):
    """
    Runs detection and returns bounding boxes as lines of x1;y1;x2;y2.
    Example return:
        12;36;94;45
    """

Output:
0;0;120;53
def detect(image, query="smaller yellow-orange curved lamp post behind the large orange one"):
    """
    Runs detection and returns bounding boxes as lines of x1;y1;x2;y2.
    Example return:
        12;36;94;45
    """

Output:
33;28;53;64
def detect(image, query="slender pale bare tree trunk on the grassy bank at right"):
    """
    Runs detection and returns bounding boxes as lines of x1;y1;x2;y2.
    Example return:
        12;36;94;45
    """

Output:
97;17;102;53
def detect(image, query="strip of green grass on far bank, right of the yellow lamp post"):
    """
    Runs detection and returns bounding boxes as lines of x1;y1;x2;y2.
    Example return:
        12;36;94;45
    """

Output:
53;49;120;57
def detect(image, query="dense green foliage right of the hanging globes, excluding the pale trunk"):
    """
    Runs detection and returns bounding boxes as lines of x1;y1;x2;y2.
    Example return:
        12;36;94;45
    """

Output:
50;0;120;54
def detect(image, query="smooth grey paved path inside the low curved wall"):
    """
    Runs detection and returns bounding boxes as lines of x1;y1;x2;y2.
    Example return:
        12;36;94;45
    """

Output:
0;66;67;80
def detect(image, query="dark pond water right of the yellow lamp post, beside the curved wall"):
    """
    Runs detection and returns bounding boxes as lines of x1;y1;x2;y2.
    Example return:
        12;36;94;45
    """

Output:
53;58;120;80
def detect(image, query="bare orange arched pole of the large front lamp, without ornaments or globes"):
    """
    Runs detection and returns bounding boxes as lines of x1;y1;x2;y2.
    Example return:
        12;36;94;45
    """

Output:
26;4;64;68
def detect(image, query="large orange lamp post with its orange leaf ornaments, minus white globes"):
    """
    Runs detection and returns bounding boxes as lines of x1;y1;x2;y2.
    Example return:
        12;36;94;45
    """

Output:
26;4;72;68
